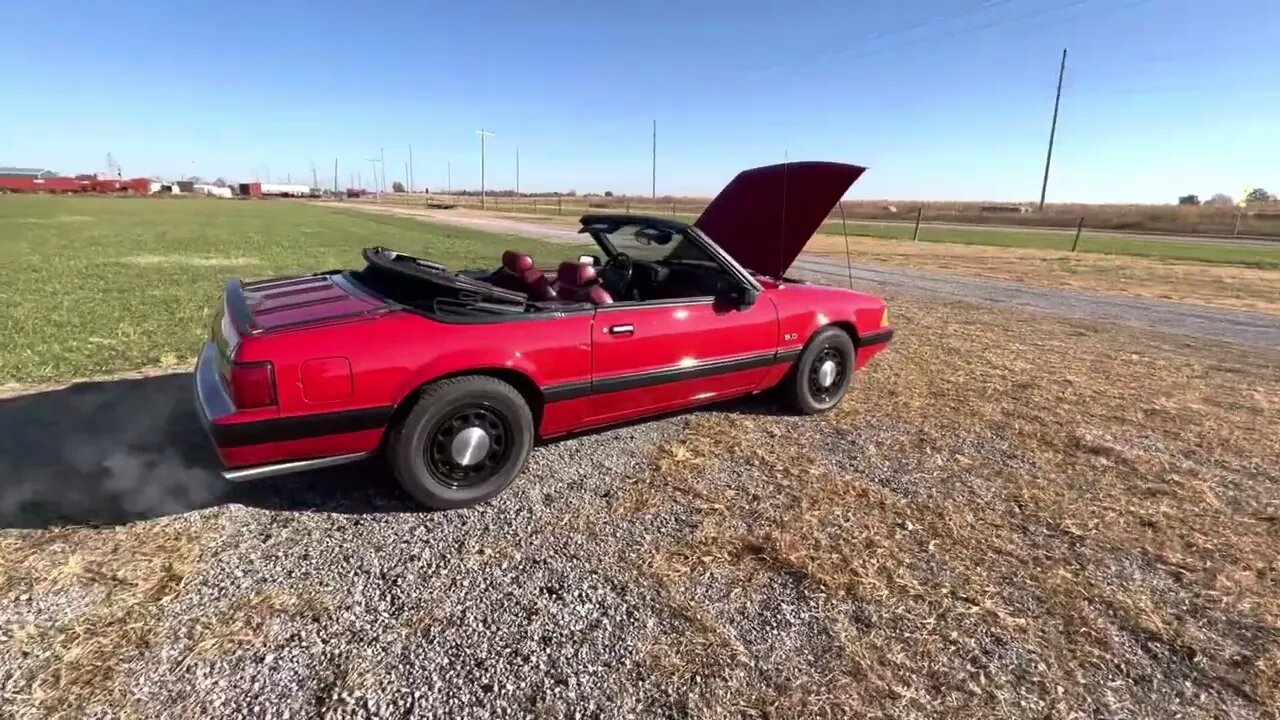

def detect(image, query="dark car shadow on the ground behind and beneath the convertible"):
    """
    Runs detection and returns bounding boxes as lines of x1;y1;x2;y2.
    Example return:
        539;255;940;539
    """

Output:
0;373;776;528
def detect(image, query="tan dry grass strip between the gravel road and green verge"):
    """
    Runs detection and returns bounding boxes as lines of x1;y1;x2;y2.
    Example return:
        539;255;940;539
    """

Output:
806;236;1280;313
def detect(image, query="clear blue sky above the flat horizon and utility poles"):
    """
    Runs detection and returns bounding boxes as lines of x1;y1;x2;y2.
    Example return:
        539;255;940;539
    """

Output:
0;0;1280;202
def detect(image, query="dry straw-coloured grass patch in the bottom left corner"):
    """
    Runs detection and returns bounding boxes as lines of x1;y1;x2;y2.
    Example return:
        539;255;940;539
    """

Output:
0;523;198;717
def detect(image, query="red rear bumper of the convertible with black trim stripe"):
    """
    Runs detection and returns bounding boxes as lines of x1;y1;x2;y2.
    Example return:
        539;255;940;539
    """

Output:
192;342;380;482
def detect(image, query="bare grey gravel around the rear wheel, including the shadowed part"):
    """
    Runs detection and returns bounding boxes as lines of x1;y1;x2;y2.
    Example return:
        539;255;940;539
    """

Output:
0;373;687;717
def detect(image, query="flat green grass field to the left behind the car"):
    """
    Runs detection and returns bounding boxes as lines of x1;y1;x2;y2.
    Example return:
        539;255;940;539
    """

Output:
0;196;577;384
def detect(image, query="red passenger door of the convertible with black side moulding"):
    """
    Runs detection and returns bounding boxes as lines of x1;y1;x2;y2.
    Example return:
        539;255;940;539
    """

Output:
590;296;778;424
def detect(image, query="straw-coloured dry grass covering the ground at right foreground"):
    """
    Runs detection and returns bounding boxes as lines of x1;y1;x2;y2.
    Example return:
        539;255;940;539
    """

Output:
621;297;1280;717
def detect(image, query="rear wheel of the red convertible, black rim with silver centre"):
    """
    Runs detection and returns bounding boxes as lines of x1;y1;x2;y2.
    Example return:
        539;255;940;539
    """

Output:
387;375;534;510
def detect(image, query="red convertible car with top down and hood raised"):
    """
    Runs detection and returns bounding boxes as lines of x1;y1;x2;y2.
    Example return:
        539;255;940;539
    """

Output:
195;163;893;507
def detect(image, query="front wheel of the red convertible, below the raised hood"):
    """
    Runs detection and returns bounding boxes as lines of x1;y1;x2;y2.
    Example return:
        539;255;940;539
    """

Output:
780;327;856;415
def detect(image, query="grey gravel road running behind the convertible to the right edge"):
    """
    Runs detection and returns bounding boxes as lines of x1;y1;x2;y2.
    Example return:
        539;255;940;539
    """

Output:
332;204;1280;347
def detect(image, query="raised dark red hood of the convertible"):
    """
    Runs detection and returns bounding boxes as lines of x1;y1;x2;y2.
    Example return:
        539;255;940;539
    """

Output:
694;161;867;277
